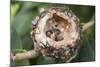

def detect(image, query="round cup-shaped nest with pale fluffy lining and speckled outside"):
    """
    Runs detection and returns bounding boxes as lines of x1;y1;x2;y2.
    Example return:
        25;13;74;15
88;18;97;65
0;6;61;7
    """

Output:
31;7;80;62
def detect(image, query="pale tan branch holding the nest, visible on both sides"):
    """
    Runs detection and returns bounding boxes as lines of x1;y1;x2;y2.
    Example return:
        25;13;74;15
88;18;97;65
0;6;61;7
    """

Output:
11;19;95;60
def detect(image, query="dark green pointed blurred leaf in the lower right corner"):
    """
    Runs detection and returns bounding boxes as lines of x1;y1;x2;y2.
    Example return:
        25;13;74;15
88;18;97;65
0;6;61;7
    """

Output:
78;34;95;62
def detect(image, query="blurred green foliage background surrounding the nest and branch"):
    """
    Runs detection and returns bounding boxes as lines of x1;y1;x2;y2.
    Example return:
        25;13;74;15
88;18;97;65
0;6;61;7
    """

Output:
10;0;95;65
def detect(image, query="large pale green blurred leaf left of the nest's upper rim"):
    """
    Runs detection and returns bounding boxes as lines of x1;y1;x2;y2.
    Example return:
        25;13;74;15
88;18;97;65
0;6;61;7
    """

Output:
12;2;39;36
